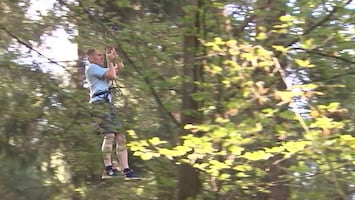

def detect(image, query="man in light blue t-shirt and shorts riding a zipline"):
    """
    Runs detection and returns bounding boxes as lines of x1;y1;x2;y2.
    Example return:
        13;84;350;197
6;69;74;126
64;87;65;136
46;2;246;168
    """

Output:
85;48;139;179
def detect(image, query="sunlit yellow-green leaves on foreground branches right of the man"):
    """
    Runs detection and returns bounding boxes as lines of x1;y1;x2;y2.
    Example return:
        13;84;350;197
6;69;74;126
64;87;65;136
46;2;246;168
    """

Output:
130;38;354;199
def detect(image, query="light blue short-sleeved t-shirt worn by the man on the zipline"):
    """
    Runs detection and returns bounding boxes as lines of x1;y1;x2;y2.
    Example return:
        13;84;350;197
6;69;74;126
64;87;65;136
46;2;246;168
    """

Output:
85;63;111;103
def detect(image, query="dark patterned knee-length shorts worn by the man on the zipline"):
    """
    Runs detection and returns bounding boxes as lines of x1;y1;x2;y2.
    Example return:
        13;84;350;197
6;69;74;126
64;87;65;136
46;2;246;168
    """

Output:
91;101;123;134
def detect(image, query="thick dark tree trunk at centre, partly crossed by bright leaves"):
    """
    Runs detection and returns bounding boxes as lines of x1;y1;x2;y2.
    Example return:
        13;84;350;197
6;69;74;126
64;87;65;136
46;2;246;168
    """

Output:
178;0;202;200
